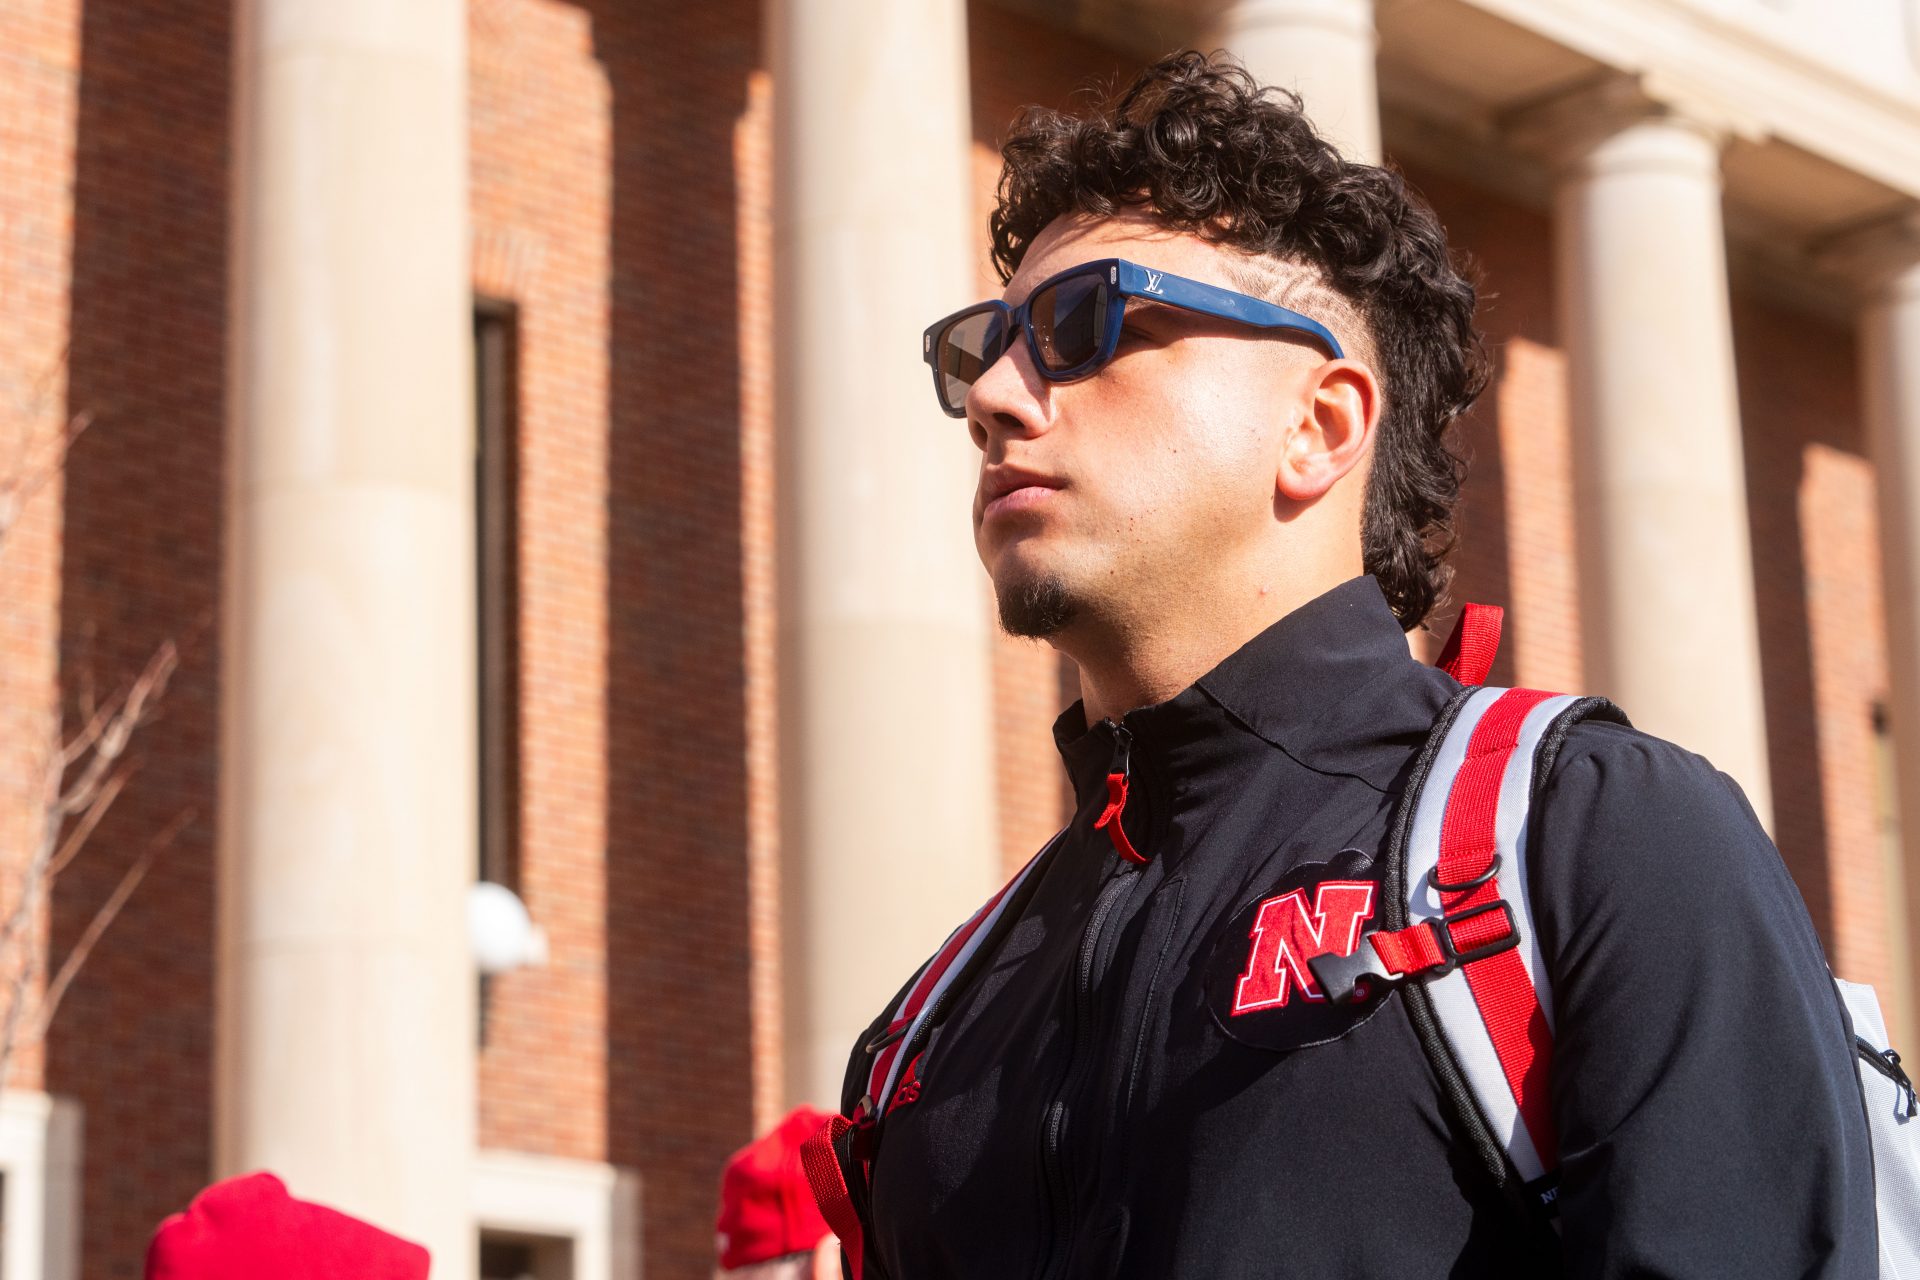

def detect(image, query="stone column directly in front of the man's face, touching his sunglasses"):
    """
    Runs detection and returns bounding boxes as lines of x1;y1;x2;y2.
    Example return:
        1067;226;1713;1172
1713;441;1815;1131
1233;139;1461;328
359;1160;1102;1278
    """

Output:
768;0;998;1102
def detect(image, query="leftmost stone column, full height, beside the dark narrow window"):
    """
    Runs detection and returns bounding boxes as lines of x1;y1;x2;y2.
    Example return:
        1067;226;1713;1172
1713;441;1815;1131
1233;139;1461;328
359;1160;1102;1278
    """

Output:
215;0;478;1278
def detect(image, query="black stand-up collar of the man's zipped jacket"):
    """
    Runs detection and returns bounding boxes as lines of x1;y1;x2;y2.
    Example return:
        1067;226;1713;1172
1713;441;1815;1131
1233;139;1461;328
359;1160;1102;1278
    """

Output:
1054;576;1459;839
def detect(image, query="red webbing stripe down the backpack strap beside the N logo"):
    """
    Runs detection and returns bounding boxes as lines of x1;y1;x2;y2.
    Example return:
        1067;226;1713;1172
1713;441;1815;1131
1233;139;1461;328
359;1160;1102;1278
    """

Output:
1436;689;1559;1169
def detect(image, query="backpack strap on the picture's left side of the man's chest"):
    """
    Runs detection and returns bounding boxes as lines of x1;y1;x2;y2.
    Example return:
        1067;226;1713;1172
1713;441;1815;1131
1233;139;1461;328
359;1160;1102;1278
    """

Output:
801;831;1066;1280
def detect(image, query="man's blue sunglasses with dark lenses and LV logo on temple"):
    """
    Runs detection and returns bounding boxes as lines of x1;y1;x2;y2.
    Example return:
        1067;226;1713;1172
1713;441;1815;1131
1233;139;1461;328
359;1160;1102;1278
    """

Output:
922;257;1344;418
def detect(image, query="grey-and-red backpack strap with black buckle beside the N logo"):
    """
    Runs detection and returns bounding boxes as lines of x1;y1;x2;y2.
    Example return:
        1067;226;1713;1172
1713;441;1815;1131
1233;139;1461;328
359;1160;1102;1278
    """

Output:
1309;687;1624;1217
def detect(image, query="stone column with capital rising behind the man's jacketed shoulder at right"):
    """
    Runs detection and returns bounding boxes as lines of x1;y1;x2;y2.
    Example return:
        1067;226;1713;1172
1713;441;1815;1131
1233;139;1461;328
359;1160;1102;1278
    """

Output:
1532;86;1772;823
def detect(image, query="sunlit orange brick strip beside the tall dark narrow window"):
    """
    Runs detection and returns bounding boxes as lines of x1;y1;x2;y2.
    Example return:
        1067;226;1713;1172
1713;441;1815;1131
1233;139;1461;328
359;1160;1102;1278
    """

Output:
468;0;612;1159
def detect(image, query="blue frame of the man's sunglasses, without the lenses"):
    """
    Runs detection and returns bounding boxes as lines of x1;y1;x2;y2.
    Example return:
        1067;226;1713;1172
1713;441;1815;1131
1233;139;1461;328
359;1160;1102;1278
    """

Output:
920;257;1346;418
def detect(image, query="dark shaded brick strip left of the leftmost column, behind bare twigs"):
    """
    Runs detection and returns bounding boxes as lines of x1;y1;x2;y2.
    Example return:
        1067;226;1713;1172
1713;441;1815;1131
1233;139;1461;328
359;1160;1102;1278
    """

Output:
46;0;232;1280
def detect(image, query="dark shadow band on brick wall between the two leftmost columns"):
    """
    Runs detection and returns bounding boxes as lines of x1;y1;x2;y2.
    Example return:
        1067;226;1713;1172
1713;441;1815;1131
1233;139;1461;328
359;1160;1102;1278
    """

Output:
584;0;760;1280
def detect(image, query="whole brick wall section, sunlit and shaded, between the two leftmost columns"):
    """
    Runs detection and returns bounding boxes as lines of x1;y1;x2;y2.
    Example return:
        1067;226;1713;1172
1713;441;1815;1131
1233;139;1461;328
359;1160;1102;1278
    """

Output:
472;0;760;1278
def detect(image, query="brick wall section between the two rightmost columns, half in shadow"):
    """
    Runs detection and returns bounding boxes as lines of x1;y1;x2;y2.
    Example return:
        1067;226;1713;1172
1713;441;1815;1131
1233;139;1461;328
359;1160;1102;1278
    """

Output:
1734;292;1910;1036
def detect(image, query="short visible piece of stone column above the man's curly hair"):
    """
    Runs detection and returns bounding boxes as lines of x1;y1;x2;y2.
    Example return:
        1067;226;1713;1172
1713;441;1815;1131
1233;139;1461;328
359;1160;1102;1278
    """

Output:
1200;0;1380;165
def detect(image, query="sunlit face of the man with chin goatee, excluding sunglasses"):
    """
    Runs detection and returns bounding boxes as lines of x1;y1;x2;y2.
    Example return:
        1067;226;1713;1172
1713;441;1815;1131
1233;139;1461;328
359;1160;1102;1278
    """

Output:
966;211;1325;635
